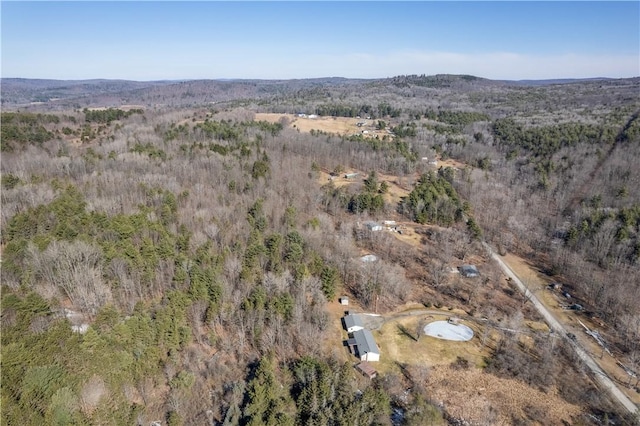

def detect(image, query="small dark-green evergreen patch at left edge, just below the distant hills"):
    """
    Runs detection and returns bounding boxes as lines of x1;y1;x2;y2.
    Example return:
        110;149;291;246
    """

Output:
0;112;60;151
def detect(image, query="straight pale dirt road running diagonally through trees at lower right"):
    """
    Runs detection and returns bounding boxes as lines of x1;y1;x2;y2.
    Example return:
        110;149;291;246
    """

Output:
484;243;638;414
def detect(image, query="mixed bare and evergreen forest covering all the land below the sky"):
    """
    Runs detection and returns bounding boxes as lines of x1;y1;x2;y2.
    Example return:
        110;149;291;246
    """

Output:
0;76;640;425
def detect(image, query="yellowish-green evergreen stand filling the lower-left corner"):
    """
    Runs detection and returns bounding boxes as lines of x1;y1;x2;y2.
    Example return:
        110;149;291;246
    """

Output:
2;291;200;425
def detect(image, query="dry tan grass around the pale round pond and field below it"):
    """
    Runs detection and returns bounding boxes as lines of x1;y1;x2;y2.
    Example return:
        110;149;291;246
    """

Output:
373;312;582;425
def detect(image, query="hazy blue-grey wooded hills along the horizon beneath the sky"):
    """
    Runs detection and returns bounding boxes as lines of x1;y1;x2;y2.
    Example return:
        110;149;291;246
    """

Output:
1;74;633;110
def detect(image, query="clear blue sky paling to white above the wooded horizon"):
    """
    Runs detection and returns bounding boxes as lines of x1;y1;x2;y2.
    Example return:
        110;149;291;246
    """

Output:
0;1;640;80
